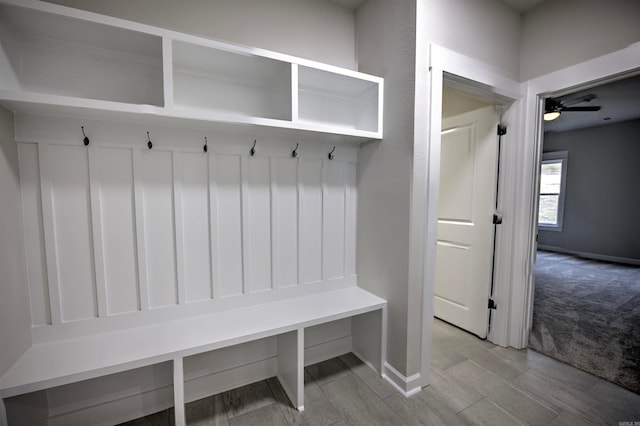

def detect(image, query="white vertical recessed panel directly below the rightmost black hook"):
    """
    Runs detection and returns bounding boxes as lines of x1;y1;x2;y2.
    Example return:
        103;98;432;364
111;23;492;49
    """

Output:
323;161;346;280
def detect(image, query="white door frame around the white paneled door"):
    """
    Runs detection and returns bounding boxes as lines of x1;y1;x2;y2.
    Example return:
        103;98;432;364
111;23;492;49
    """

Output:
414;44;524;386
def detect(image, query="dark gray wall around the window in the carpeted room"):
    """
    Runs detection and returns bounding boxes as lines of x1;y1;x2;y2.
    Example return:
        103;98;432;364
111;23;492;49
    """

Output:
538;120;640;260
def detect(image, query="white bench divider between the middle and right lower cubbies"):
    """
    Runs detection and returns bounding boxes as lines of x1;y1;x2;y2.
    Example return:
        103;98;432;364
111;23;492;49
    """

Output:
278;328;304;411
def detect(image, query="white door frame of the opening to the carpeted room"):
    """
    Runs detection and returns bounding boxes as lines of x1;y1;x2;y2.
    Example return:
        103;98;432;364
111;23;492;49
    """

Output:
520;42;640;342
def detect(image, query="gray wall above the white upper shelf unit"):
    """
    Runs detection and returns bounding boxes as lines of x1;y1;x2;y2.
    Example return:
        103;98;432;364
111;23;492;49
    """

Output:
47;0;356;69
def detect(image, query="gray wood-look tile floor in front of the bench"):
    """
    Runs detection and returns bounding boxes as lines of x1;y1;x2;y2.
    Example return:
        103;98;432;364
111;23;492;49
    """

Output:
127;320;640;426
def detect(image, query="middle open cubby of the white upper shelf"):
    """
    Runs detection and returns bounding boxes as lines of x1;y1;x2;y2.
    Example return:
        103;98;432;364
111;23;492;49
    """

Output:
173;41;291;120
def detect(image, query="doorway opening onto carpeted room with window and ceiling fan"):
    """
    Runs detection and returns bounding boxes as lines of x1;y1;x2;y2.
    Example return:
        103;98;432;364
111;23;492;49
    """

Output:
529;75;640;393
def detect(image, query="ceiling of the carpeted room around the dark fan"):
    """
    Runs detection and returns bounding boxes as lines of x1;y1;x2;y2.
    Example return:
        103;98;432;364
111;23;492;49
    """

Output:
544;75;640;132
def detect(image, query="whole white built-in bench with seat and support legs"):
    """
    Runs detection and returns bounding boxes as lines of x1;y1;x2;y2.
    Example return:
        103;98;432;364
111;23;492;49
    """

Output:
0;287;386;425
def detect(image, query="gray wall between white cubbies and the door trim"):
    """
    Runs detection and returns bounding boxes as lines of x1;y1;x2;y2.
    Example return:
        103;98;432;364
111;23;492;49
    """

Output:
356;0;416;375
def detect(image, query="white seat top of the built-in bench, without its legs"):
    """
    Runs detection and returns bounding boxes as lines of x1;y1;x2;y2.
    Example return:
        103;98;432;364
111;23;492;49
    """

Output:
0;287;386;398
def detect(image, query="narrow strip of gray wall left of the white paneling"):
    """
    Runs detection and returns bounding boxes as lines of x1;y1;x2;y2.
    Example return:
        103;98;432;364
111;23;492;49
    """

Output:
0;107;31;375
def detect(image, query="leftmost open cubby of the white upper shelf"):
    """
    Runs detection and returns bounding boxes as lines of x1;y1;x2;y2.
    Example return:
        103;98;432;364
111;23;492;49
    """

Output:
0;5;164;106
